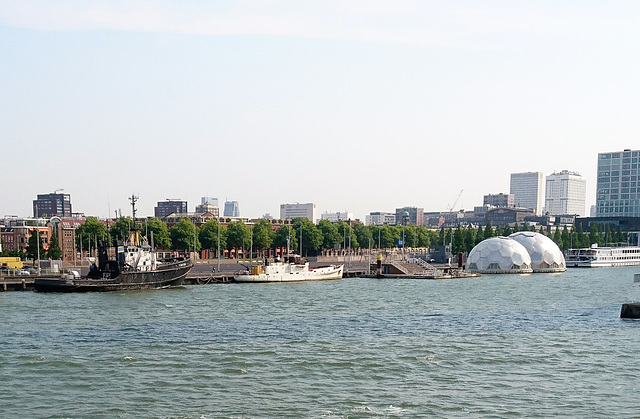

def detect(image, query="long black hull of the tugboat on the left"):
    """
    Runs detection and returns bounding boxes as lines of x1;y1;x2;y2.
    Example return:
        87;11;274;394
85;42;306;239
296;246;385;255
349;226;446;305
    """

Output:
33;261;193;292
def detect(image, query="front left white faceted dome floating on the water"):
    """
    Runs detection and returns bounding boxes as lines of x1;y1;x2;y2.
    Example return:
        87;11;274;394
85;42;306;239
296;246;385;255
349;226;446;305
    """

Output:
466;237;533;274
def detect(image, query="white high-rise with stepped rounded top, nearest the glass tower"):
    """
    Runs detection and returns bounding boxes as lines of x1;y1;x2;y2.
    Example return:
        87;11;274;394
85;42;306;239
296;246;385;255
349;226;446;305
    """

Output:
544;170;587;217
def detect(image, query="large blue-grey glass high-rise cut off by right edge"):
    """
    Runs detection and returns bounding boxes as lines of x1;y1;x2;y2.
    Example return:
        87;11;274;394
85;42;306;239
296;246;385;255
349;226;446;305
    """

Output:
596;149;640;217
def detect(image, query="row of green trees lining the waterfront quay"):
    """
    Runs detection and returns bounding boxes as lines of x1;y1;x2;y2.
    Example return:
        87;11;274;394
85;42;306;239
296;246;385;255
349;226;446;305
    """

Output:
3;217;627;259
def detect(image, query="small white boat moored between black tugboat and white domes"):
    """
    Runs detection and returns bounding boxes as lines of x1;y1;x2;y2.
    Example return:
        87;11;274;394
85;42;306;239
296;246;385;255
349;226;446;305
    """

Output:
234;254;344;282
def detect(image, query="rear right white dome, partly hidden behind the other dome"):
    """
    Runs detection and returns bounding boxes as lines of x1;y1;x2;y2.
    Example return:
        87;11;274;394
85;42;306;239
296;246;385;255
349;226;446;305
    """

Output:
509;231;567;272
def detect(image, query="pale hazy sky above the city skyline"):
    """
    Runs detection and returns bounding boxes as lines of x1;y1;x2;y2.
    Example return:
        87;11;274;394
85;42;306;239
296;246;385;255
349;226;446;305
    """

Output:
0;0;640;220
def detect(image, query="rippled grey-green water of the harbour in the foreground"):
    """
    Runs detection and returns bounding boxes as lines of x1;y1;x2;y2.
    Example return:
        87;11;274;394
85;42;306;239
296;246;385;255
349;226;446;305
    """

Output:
0;268;640;419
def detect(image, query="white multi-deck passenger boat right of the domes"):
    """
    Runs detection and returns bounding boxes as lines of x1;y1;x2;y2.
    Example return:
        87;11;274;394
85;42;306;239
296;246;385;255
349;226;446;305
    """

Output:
565;245;640;268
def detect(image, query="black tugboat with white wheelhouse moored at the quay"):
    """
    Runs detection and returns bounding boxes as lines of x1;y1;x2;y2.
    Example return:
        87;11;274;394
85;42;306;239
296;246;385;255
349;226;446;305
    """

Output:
33;231;193;292
